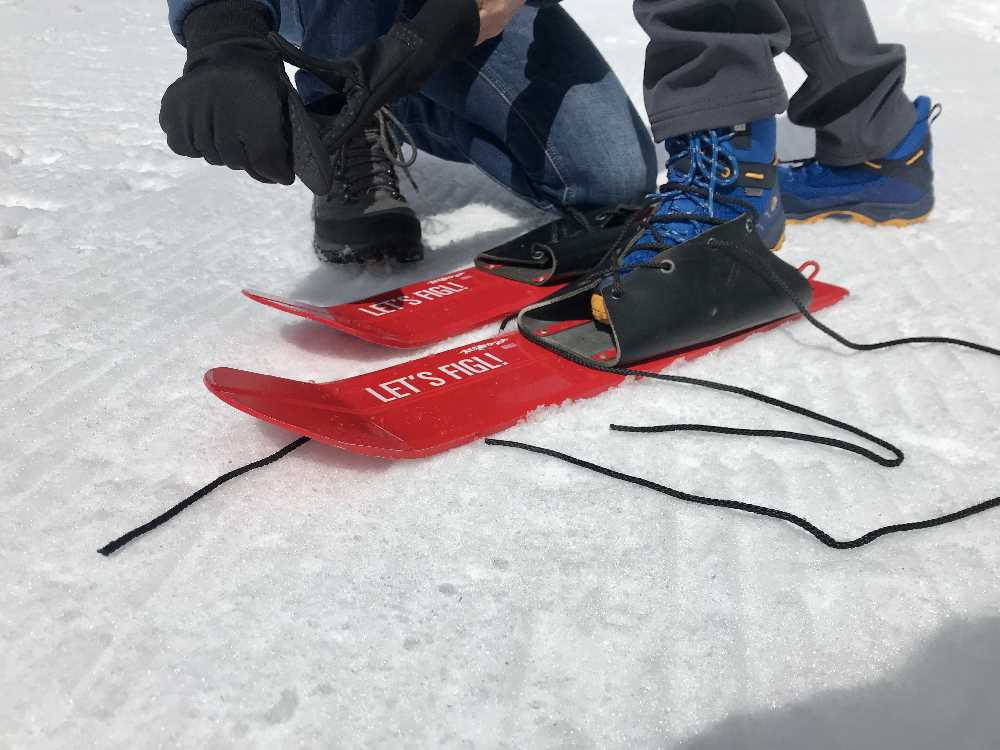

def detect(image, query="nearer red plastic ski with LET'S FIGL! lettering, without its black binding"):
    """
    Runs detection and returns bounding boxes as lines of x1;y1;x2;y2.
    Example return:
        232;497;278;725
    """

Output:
205;268;847;459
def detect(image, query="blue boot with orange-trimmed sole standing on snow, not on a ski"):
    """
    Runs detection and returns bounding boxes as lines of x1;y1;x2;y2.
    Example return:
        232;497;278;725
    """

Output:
778;96;940;227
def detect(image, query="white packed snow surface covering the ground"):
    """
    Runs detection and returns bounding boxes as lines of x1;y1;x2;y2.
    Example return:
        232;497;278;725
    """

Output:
0;0;1000;750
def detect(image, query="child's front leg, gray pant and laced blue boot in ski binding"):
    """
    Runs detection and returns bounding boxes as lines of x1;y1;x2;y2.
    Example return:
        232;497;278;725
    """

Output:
634;0;790;253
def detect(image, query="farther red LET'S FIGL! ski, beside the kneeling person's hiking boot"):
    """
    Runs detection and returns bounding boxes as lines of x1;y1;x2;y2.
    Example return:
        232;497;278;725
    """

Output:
243;268;560;349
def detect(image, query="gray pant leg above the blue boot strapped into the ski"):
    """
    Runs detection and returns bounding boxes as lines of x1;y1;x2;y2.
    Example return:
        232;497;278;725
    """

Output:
633;0;788;141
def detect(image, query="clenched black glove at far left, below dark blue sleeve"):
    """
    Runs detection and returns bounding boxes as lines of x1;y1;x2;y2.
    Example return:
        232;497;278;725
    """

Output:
160;0;332;195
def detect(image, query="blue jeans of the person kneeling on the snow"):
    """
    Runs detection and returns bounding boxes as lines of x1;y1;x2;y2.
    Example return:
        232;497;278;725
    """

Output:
281;0;657;209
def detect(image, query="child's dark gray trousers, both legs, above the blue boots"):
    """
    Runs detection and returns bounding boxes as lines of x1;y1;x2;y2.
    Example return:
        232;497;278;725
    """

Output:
634;0;916;165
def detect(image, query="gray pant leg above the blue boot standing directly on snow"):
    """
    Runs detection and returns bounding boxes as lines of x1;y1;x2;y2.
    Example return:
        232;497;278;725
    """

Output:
777;0;916;166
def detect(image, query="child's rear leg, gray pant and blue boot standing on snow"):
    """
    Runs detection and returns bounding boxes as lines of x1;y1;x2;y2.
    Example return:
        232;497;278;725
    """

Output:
778;0;934;226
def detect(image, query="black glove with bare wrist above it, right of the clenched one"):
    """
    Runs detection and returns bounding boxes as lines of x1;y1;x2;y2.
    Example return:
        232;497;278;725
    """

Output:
270;0;479;154
